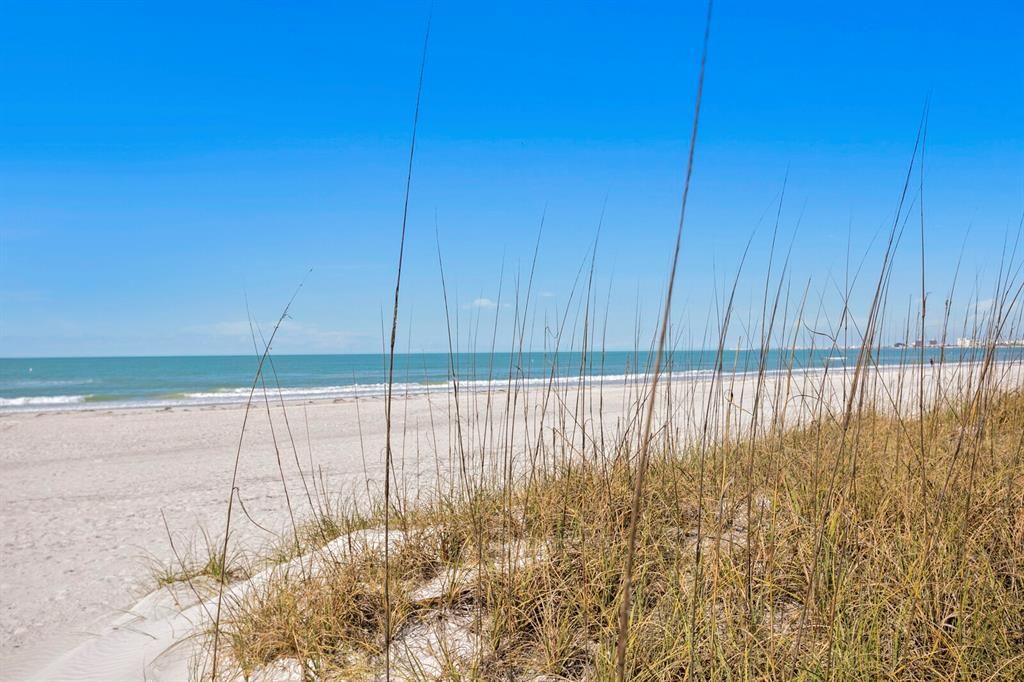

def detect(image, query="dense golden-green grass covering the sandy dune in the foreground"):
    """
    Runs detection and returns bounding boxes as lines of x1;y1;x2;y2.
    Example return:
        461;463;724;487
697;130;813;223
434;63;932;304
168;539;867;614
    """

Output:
190;368;1024;680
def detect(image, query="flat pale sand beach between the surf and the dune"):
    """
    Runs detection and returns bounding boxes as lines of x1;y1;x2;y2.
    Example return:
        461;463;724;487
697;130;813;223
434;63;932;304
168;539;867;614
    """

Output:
0;358;1022;680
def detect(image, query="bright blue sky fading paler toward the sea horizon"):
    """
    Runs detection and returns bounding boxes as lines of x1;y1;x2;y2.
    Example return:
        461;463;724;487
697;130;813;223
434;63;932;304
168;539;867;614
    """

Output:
0;0;1024;356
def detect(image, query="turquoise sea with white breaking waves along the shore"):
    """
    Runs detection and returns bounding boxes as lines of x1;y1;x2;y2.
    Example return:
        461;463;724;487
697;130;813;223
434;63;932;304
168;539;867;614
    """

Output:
0;348;1024;412
